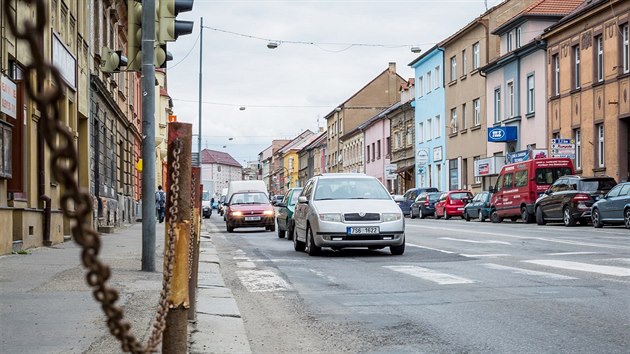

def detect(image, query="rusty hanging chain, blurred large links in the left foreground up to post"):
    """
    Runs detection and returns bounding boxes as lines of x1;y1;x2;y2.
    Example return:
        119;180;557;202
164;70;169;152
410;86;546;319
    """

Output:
2;0;181;353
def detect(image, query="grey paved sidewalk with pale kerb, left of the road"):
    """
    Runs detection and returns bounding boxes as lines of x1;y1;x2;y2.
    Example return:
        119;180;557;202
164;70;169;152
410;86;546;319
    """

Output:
0;223;251;353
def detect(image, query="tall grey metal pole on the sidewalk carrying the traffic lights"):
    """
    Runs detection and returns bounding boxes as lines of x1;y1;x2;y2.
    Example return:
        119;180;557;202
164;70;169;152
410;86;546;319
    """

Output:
142;0;157;272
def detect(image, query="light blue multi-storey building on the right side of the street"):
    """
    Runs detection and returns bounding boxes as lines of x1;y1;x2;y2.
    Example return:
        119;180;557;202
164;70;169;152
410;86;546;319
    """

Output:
409;45;448;190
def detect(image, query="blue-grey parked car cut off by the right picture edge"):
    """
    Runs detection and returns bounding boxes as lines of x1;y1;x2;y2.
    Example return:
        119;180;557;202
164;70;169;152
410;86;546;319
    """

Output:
591;182;630;229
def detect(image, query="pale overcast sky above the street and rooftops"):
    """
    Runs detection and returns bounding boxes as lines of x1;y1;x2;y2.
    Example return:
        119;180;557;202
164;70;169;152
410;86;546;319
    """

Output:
168;0;500;165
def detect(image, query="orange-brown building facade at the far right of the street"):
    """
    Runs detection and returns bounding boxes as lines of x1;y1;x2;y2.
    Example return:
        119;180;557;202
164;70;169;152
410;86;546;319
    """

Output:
542;0;630;182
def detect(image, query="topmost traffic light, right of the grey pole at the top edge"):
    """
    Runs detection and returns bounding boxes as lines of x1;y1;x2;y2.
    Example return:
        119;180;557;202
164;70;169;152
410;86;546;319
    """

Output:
157;0;194;44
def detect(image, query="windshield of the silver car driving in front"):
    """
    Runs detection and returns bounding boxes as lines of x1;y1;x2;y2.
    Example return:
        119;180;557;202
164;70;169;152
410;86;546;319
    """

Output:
315;178;391;200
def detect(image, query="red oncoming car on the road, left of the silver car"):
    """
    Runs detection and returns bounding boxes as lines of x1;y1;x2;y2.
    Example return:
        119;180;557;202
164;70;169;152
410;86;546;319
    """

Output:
225;191;276;232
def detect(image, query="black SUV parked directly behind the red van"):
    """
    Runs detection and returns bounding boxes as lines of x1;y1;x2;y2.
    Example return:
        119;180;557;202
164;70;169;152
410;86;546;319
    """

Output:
534;175;617;226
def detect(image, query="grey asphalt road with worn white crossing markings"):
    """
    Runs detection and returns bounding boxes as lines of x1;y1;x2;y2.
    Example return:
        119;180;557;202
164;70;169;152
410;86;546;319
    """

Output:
204;214;630;353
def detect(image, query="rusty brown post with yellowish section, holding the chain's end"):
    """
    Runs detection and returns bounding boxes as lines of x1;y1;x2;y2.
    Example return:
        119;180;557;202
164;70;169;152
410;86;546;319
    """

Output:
162;123;193;353
